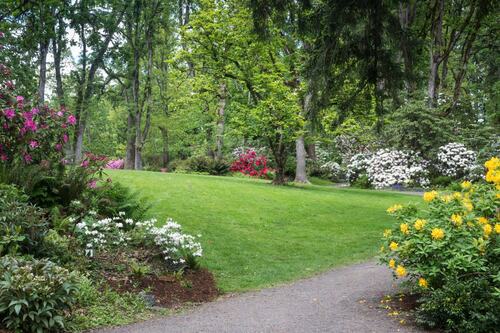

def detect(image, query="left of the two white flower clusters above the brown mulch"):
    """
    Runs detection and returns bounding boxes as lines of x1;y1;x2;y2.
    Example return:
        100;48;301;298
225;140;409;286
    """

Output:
74;211;133;257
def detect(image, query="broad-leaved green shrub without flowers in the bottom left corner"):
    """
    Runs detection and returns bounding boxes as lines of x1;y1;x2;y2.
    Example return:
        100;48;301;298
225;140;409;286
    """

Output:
0;256;77;333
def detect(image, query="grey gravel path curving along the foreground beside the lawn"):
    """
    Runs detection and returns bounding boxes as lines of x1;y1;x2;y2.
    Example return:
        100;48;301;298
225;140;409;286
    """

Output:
96;262;421;333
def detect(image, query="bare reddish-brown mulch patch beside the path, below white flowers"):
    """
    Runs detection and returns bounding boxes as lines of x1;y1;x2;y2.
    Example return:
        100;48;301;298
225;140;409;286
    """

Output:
107;269;219;308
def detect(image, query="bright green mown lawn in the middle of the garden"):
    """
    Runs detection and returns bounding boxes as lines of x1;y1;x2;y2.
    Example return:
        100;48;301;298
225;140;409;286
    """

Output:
109;171;417;291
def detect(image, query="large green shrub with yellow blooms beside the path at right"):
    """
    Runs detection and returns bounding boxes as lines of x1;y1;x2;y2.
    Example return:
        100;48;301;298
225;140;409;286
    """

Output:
380;158;500;332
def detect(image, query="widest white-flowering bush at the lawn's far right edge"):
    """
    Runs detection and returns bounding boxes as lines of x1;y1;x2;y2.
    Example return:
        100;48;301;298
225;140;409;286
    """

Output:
366;149;429;188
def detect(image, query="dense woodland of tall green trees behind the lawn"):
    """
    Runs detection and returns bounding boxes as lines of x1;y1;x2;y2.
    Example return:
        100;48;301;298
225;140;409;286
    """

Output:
0;0;500;183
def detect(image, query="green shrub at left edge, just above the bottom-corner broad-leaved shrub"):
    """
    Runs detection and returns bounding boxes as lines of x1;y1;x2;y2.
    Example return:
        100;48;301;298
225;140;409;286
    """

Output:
0;184;48;255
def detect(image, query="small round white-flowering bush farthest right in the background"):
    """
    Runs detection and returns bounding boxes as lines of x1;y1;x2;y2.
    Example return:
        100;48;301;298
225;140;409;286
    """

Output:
436;142;477;177
